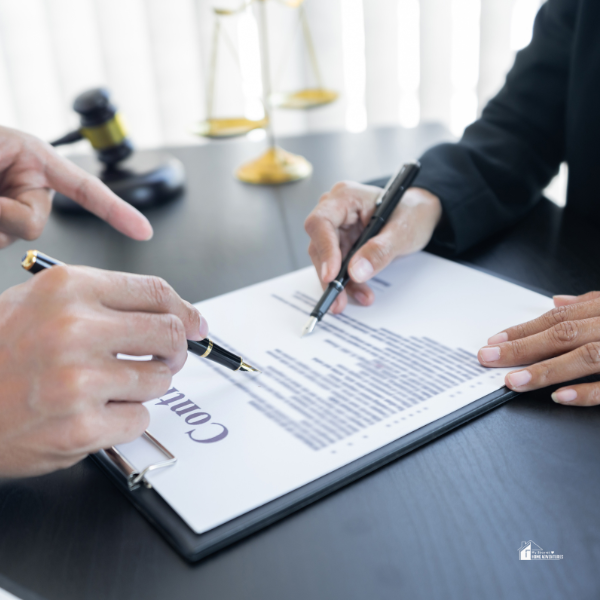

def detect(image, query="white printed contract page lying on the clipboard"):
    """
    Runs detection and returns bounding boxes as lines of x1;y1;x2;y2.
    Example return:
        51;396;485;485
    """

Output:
119;253;553;533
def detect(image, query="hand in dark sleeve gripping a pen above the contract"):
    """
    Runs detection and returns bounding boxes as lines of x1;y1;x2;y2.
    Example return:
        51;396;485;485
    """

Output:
304;182;442;314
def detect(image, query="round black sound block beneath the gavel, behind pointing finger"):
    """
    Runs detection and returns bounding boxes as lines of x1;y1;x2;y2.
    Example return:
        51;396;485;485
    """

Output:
52;151;185;214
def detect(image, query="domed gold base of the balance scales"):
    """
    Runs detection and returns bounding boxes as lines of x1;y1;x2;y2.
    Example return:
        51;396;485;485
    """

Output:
235;146;312;185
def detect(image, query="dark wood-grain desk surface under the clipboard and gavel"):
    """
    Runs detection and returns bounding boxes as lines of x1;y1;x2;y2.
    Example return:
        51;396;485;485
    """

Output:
0;126;600;600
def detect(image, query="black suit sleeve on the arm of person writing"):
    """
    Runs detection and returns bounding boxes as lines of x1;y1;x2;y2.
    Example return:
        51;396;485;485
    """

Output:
414;0;579;253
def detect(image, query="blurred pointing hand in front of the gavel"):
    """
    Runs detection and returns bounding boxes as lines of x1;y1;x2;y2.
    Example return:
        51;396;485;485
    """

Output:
0;127;152;248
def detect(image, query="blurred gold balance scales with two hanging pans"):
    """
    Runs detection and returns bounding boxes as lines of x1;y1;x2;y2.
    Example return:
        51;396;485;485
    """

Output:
194;0;338;185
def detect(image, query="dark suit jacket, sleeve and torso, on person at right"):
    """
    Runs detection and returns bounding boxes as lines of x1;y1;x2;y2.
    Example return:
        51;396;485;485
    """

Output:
414;0;600;252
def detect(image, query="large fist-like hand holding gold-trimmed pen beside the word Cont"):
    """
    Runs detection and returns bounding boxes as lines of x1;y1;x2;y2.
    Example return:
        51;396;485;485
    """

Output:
0;266;208;477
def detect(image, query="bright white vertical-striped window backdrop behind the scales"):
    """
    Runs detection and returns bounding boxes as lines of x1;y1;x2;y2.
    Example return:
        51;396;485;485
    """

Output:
0;0;566;202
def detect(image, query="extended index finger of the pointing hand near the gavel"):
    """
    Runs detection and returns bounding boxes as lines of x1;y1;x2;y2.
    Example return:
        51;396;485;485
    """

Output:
46;149;152;240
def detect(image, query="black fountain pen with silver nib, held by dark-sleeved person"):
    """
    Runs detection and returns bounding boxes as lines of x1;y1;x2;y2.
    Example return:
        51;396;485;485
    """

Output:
302;160;421;336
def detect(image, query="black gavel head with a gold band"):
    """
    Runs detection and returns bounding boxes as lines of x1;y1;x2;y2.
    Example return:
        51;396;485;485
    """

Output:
73;88;133;166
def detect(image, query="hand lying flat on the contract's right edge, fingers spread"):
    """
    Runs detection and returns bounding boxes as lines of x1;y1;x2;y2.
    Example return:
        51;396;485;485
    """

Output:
478;292;600;406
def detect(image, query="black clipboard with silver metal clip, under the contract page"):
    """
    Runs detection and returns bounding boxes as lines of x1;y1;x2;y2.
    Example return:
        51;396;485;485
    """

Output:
91;387;517;562
